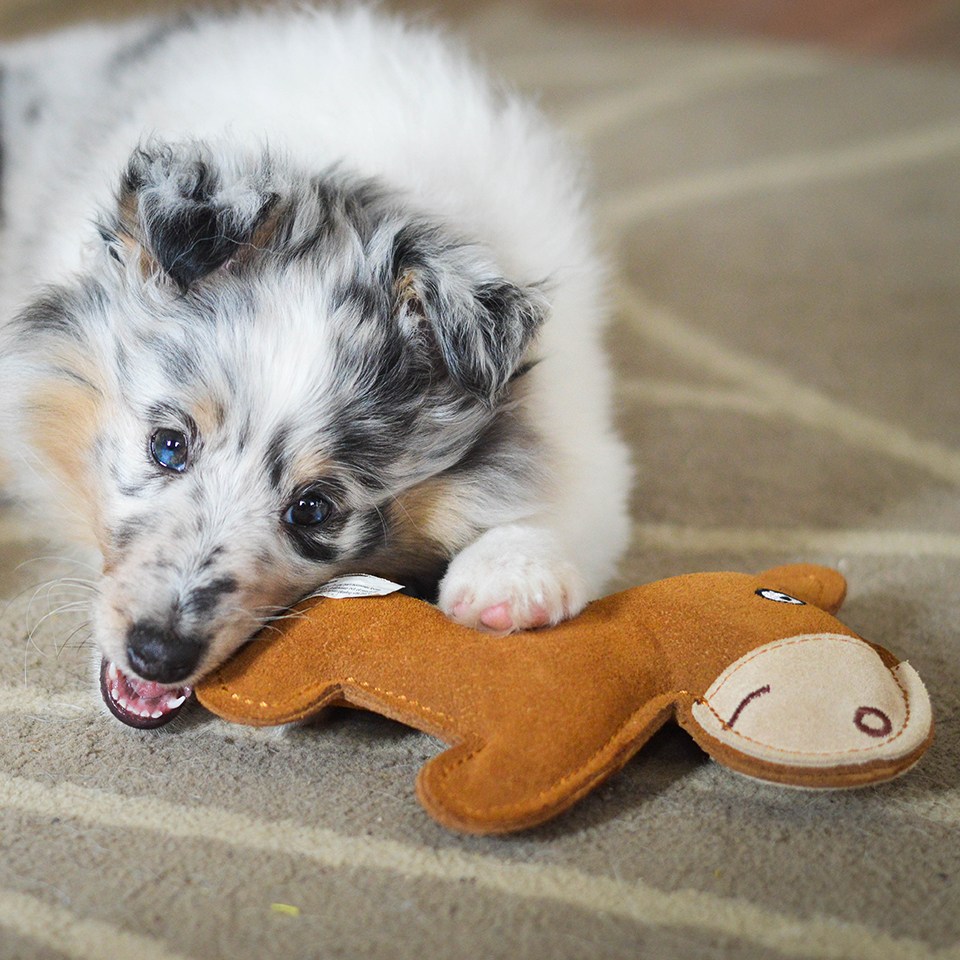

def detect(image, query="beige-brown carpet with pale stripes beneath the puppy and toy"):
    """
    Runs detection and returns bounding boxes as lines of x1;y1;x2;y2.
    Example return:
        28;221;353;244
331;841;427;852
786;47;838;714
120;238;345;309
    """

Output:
0;3;960;960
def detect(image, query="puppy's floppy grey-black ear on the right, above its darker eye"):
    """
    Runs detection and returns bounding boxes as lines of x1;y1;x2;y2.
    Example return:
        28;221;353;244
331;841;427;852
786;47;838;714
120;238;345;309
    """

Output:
392;226;547;403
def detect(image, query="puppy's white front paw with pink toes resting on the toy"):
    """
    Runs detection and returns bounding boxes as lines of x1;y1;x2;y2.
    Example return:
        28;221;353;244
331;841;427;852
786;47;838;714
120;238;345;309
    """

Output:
439;526;587;633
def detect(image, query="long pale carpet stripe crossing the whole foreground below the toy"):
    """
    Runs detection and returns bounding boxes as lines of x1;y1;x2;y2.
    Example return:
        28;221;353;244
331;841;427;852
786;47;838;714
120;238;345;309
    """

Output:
0;774;960;960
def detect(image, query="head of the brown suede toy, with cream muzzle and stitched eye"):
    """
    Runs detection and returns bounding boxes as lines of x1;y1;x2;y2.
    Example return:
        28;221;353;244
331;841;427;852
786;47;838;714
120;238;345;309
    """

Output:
628;565;932;788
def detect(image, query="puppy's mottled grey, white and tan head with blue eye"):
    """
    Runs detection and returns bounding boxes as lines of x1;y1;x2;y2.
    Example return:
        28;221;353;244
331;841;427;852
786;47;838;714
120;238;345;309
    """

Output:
4;144;545;716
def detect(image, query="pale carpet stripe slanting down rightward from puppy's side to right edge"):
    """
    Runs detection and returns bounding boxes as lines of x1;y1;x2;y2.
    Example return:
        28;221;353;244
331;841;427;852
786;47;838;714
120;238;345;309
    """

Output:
617;282;960;486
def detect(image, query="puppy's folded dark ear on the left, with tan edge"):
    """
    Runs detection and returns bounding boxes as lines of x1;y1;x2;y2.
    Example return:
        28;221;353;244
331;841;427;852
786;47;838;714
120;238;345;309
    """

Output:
106;143;278;292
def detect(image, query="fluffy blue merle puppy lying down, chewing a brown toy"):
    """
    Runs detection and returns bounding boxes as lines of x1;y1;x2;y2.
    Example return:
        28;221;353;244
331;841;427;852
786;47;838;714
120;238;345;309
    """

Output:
0;8;630;726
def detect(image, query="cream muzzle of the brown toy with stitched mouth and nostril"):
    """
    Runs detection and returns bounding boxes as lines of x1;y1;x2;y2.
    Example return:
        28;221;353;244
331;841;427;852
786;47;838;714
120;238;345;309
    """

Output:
691;633;933;787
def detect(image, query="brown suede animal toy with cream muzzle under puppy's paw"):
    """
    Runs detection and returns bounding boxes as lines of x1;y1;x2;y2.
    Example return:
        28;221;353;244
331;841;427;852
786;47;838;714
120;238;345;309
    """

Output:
197;565;933;833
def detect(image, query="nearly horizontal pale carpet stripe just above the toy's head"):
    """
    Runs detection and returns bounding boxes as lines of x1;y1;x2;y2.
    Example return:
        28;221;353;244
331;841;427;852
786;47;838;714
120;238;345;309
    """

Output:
633;523;960;559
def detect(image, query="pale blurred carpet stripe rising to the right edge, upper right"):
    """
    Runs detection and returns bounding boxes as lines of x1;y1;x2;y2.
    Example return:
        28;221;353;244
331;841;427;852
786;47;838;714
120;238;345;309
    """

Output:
601;123;960;231
